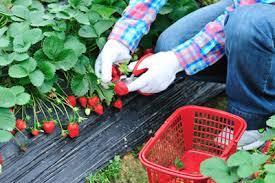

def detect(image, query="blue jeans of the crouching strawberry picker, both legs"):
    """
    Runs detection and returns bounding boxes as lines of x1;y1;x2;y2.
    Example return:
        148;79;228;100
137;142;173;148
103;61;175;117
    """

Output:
155;0;275;130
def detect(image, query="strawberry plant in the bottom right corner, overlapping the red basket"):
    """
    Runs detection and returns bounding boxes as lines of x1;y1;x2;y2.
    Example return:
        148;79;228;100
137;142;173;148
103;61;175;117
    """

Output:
200;116;275;183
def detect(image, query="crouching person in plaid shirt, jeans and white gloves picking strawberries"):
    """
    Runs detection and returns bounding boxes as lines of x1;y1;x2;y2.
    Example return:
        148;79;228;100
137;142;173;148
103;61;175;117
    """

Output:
95;0;275;150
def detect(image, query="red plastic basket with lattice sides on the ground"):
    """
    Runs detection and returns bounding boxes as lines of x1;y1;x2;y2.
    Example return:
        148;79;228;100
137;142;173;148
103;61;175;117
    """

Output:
139;106;246;183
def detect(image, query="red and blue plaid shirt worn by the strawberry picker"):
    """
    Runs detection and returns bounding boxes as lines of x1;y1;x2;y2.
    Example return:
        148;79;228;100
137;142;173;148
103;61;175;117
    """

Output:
109;0;275;75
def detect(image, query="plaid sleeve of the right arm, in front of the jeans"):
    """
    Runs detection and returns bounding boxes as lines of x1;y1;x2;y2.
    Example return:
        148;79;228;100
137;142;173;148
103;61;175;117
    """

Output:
173;14;227;75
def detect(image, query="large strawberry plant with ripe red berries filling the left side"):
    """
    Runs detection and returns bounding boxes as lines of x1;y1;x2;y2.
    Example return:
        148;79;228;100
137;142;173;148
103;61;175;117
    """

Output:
0;0;202;152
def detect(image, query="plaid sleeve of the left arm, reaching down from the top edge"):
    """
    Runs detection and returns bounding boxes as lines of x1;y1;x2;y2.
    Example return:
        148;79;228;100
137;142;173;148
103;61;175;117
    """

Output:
109;0;167;51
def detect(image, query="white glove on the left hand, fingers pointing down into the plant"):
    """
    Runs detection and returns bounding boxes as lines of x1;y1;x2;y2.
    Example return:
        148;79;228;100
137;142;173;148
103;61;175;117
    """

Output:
95;39;131;83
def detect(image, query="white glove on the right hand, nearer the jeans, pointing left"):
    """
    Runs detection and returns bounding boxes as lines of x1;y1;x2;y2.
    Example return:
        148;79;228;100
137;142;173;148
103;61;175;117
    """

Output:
128;51;183;93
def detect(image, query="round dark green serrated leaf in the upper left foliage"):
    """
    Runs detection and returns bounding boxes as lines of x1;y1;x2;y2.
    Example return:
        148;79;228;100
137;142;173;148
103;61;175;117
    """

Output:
42;36;64;59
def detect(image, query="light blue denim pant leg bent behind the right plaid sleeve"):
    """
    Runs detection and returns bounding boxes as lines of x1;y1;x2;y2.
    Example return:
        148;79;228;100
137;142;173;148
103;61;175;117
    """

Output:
155;0;232;83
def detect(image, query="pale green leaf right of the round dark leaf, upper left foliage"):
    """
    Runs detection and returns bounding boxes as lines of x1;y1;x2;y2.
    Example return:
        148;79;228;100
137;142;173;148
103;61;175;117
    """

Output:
64;36;86;57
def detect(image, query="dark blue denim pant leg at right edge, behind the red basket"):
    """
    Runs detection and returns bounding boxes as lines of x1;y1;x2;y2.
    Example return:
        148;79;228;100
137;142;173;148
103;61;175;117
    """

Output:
225;4;275;130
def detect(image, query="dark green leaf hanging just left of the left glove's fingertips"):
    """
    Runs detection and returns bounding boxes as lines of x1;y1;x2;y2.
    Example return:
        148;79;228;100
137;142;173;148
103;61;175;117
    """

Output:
71;75;89;96
